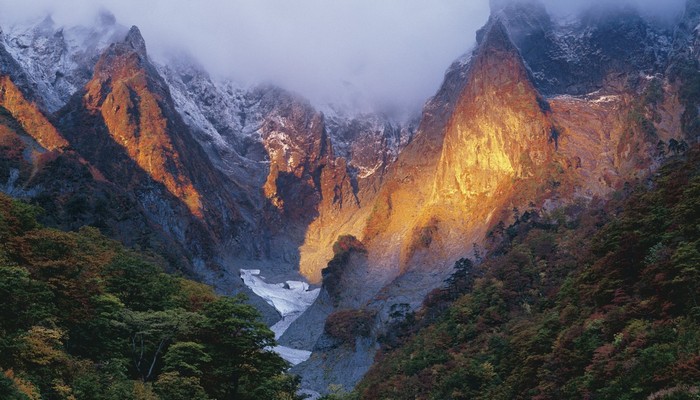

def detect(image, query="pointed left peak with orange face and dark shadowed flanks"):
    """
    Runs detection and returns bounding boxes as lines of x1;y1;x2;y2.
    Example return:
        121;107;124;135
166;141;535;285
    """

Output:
51;27;256;282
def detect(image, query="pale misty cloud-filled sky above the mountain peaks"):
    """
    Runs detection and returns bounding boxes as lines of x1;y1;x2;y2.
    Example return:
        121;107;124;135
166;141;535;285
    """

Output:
0;0;684;117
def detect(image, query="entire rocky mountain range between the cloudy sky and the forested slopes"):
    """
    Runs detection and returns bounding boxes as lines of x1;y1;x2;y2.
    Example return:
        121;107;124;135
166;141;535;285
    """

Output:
0;0;700;392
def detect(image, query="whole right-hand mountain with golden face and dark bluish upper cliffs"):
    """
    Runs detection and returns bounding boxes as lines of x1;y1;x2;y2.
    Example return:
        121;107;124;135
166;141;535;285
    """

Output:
288;2;698;389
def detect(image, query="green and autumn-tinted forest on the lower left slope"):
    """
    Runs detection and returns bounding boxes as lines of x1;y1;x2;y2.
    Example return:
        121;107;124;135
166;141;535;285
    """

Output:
0;194;299;400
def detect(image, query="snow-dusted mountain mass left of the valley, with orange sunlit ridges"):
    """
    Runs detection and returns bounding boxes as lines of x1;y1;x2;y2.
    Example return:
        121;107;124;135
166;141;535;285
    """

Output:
0;9;413;352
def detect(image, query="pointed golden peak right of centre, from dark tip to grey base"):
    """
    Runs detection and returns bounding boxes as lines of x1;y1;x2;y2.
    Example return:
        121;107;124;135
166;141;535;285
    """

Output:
342;19;555;290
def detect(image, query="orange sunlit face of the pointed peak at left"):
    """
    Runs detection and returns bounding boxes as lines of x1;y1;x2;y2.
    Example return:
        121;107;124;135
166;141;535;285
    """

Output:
83;27;203;218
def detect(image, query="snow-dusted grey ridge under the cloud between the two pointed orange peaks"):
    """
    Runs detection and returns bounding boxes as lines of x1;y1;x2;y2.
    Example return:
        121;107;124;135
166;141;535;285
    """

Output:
156;49;417;184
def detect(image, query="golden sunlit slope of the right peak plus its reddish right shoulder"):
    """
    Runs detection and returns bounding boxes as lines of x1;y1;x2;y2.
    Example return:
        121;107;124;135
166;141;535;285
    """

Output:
300;18;682;294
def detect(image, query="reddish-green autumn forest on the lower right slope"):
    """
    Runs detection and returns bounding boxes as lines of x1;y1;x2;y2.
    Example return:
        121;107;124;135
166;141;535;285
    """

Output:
346;150;700;400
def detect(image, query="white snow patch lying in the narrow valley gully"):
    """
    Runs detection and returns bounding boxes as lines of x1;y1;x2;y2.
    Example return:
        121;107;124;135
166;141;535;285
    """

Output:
241;269;321;365
